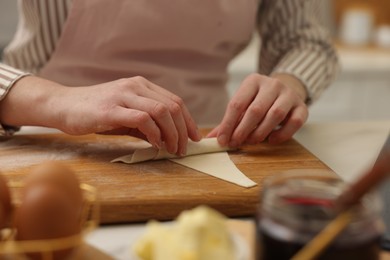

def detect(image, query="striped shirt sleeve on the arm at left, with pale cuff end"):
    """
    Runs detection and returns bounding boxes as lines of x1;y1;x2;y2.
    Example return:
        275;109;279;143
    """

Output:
0;0;72;135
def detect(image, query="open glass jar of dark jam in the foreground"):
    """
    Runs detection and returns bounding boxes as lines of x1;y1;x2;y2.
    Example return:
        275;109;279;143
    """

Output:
257;172;384;260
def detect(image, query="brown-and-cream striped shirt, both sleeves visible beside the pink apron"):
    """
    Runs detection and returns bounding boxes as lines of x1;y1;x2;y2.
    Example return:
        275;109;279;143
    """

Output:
0;0;338;135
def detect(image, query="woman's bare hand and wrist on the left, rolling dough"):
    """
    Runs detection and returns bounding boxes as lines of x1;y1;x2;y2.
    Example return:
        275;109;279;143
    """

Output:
0;76;201;155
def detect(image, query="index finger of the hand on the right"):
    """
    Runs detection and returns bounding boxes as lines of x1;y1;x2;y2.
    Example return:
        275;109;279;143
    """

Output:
218;82;258;146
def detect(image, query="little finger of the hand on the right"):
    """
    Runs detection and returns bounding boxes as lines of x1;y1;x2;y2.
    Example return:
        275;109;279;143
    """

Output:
268;106;309;144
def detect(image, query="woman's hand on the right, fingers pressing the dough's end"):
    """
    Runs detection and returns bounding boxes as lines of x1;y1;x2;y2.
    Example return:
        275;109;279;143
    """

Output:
208;74;308;147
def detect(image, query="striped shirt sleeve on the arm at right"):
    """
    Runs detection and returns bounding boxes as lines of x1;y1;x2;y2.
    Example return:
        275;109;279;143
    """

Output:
258;0;339;103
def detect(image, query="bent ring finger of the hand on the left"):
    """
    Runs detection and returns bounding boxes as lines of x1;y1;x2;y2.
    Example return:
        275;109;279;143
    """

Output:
121;95;179;154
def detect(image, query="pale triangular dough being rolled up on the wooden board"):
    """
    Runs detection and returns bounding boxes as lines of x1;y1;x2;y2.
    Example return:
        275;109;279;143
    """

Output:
111;138;256;188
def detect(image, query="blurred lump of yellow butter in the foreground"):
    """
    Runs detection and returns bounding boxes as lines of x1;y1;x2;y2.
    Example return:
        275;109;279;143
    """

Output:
133;206;235;260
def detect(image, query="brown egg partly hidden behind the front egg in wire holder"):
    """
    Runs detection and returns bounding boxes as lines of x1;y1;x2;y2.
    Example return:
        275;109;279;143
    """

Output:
24;161;83;213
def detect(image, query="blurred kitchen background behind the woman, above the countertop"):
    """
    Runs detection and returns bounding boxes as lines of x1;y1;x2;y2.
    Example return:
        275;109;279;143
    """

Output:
0;0;390;122
